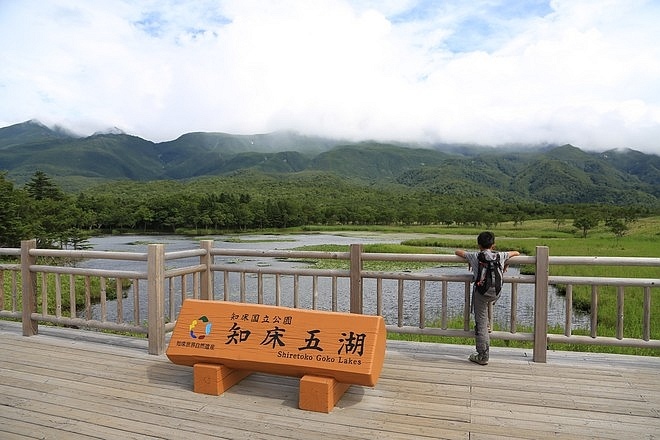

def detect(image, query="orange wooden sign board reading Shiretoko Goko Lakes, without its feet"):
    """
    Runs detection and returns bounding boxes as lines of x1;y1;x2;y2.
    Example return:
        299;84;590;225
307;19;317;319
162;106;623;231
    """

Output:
166;299;386;386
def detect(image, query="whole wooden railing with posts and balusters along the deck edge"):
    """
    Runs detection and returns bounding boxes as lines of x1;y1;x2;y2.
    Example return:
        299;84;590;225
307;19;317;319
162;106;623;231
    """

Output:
0;240;660;362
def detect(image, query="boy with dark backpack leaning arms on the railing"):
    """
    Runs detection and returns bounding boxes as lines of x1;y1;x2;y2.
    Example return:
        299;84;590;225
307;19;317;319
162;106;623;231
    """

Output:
455;231;520;365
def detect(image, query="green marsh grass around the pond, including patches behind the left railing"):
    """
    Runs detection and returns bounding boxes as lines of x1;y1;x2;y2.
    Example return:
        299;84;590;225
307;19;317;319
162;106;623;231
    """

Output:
2;216;660;356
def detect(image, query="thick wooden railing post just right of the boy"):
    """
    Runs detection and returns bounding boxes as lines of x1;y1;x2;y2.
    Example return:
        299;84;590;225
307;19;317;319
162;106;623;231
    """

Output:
532;246;550;363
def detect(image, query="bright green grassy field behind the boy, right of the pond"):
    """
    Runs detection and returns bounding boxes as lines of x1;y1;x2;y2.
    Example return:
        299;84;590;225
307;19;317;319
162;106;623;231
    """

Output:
296;217;660;356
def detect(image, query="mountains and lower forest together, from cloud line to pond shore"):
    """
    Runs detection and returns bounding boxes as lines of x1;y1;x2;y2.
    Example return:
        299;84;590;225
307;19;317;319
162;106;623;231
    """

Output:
0;121;660;248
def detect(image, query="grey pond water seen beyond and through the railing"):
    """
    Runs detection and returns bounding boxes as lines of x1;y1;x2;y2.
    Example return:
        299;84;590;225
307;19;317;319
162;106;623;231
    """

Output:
78;232;589;329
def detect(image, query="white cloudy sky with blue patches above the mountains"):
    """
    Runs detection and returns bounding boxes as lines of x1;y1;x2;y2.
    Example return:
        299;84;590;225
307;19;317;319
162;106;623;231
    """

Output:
0;0;660;154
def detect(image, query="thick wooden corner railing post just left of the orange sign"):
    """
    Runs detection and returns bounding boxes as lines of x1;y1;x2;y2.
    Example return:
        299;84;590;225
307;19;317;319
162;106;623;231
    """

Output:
147;244;165;355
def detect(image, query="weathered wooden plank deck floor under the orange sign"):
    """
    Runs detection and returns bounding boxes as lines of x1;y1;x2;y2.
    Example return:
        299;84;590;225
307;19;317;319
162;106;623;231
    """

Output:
0;321;660;440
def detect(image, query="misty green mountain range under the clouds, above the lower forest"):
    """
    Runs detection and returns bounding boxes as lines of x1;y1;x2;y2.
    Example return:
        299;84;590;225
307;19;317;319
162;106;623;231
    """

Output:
0;121;660;207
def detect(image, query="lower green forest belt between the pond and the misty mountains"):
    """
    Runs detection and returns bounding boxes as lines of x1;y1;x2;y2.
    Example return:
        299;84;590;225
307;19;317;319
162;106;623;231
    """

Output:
0;170;653;249
